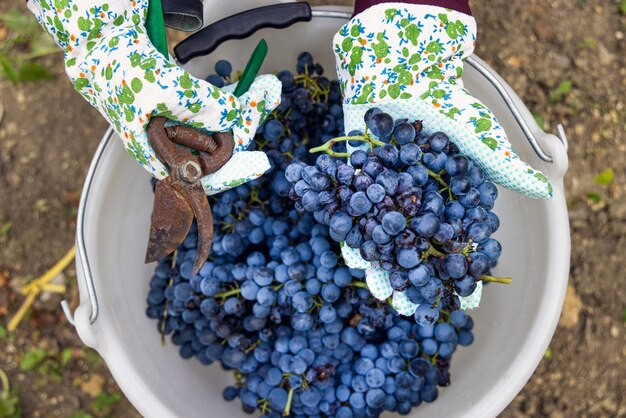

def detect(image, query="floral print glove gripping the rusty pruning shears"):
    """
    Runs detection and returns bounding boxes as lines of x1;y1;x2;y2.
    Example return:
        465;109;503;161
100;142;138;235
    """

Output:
28;0;281;194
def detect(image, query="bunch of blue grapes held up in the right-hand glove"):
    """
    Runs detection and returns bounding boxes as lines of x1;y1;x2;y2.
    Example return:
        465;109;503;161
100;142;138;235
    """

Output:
285;108;501;325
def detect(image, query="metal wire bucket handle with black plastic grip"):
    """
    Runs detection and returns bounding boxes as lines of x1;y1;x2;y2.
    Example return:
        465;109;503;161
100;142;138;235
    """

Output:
61;2;568;325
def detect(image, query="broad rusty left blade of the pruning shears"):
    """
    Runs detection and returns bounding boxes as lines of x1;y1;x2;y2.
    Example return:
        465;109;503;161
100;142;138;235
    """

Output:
146;180;194;263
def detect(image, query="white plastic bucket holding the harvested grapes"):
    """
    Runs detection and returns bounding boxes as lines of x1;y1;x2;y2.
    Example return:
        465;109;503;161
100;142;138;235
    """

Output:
66;0;570;418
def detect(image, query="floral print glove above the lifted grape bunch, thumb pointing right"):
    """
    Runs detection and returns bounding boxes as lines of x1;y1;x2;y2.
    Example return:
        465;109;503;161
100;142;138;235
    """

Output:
334;3;552;199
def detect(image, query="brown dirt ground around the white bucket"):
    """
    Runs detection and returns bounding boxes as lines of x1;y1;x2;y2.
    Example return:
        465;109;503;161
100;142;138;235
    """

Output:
0;0;626;418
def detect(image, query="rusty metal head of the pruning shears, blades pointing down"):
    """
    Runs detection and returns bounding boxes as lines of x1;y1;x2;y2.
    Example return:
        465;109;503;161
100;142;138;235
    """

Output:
146;117;234;275
